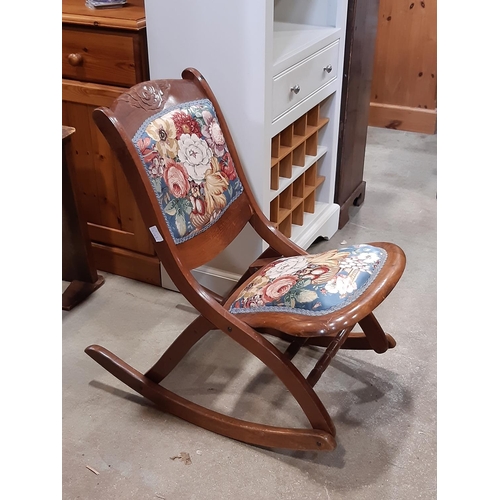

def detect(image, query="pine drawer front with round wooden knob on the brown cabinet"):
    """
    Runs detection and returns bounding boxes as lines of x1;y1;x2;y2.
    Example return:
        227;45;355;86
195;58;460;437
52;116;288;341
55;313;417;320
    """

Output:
62;28;141;87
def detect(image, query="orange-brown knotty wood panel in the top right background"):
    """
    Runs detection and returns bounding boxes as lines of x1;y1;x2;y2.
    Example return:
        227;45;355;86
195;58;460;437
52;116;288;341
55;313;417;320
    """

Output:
369;0;437;134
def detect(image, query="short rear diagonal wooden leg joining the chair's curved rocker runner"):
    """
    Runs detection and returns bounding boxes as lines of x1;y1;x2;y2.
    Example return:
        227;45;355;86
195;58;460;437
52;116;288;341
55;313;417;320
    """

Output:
144;316;215;384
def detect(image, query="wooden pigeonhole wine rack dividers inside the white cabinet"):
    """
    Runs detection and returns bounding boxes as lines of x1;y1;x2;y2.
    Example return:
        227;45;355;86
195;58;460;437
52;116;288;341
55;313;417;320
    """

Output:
269;104;328;237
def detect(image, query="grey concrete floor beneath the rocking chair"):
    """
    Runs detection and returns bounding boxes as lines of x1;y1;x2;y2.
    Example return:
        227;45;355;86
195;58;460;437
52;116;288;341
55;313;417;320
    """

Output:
62;128;437;500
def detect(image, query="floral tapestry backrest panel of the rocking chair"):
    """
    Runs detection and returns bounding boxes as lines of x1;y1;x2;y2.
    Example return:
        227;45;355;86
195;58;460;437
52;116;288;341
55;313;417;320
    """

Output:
133;99;243;244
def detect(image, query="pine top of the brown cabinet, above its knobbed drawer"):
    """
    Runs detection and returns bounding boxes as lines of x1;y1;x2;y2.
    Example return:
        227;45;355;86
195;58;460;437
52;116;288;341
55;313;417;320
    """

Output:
62;0;146;30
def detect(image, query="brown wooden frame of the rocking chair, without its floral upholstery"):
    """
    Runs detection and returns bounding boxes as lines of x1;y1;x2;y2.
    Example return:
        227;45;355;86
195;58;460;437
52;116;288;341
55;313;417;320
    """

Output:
85;64;405;450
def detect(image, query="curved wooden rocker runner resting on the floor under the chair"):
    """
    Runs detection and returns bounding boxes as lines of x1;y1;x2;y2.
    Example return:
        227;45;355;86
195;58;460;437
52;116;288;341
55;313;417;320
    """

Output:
85;345;336;451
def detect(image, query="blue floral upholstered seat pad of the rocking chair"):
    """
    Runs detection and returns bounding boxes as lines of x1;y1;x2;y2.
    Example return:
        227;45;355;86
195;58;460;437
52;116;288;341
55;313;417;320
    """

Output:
229;245;387;316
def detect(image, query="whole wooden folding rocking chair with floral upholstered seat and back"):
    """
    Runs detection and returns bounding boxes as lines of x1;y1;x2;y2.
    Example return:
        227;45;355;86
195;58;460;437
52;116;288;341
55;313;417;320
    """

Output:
85;64;405;450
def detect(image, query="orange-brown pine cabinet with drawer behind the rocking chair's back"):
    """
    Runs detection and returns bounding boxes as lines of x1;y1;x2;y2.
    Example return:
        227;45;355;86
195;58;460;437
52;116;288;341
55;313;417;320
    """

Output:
62;0;161;285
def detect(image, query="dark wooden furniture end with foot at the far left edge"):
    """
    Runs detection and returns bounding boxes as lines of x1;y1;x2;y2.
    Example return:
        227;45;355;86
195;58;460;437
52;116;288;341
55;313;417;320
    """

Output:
62;125;104;311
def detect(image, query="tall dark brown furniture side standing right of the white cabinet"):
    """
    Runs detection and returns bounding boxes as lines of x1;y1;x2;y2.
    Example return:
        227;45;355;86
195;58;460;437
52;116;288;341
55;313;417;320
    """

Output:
335;0;379;229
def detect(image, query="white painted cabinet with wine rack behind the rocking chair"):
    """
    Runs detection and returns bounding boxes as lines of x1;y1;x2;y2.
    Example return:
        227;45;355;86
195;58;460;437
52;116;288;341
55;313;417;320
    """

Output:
145;0;347;293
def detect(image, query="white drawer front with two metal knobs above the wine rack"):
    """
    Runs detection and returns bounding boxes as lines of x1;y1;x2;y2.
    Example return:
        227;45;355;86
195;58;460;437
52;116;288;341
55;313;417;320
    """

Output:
273;40;339;121
